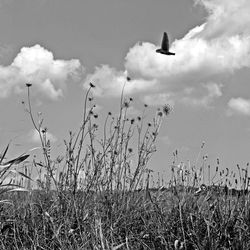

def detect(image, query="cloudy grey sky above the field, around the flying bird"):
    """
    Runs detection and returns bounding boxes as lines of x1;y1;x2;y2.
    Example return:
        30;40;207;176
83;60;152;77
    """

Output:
0;0;250;180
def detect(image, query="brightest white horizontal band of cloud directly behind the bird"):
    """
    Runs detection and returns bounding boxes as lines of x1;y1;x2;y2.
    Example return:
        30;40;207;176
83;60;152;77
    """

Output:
125;35;250;81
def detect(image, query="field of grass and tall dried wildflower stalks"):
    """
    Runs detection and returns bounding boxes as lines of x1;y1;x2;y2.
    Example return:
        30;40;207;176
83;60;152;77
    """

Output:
0;83;250;250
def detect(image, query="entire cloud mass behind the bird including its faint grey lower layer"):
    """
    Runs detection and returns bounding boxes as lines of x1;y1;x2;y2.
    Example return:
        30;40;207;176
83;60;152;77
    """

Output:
85;0;250;107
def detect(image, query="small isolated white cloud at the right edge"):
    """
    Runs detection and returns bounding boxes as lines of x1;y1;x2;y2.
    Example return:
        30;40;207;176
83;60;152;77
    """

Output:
228;97;250;115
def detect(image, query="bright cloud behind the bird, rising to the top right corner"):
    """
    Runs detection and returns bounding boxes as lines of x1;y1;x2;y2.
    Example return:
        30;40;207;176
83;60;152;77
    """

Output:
125;0;250;78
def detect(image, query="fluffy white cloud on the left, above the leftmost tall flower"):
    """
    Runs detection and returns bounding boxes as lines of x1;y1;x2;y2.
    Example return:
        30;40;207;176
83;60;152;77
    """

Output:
0;44;83;100
